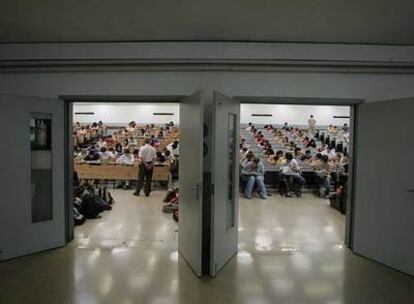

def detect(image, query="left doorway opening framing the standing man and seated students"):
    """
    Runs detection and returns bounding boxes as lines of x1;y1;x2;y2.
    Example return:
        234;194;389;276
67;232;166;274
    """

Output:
70;100;180;253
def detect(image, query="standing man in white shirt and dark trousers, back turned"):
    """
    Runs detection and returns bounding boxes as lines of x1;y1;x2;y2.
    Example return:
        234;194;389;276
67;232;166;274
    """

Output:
134;138;157;196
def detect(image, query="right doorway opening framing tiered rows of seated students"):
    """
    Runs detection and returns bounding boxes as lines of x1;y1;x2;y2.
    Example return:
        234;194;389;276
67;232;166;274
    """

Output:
238;101;354;257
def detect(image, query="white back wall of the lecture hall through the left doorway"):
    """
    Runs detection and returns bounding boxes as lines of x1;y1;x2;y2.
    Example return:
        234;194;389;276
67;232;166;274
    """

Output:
73;103;179;124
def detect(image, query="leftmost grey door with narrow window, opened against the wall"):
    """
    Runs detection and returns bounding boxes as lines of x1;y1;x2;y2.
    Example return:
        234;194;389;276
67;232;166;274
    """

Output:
0;95;65;260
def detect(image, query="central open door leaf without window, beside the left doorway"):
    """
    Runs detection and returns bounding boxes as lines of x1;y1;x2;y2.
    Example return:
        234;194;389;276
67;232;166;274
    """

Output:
178;92;203;276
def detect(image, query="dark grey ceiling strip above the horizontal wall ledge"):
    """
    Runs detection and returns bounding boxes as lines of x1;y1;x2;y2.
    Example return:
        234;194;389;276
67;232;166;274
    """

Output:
0;0;414;45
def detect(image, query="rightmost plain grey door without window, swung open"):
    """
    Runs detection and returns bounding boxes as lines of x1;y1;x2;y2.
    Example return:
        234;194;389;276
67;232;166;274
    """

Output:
353;98;414;275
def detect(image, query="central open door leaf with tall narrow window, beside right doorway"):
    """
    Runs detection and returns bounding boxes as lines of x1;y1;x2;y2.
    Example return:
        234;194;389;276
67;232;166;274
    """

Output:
210;92;240;276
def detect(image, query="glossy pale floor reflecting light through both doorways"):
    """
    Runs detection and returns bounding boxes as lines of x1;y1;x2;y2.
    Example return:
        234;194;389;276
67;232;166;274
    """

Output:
0;190;414;304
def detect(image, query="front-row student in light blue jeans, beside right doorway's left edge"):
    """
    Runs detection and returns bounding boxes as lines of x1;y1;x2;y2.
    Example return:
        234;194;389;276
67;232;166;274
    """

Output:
242;157;267;199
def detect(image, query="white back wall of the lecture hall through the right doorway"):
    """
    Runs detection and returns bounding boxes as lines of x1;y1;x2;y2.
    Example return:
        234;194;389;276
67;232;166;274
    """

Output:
240;104;350;125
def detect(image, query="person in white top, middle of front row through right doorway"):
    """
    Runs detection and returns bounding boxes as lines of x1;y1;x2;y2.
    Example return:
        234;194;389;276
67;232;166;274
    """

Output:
282;153;306;197
